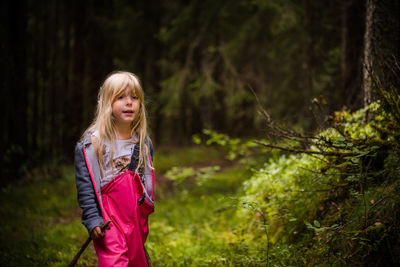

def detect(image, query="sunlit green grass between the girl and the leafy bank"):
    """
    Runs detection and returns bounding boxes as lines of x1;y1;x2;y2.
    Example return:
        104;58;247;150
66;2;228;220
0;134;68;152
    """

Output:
147;166;253;266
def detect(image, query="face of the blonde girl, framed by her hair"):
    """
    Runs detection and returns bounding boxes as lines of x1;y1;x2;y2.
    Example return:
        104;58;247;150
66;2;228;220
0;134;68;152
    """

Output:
111;88;140;126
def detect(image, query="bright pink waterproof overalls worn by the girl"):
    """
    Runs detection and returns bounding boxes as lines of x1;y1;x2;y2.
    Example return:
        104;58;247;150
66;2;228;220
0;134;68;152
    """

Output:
94;171;154;267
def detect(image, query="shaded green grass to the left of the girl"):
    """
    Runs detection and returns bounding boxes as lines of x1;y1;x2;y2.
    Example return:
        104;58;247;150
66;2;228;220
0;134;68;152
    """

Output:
0;167;95;266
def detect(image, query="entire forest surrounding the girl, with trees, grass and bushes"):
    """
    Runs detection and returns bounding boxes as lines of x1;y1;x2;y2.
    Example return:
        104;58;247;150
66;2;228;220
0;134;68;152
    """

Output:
0;0;400;266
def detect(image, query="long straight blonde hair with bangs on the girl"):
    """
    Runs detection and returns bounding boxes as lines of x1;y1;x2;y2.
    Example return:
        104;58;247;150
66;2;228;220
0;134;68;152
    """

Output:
82;71;148;175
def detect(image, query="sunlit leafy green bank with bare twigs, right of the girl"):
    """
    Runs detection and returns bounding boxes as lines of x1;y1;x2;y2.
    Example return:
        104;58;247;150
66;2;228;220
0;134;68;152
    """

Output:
199;102;400;266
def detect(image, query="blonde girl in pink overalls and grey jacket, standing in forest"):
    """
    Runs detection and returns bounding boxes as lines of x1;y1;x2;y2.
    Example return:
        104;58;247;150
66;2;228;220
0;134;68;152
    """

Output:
75;72;154;266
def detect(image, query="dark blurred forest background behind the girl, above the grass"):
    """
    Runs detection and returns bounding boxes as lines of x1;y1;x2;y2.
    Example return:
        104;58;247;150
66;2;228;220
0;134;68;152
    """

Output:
0;0;400;183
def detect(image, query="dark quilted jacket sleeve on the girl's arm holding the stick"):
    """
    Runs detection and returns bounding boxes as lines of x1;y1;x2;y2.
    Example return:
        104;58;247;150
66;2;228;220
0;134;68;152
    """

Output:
75;143;104;234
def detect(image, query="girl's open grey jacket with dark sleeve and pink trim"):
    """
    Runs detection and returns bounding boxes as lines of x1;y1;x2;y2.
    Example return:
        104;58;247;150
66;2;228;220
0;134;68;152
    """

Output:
75;135;153;234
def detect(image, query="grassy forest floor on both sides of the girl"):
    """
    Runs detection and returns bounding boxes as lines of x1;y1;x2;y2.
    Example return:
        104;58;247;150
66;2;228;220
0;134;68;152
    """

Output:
0;146;250;266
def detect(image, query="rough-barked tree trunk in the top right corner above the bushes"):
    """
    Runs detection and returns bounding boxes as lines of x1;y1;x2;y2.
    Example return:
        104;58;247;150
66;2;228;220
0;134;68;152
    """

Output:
363;0;400;110
